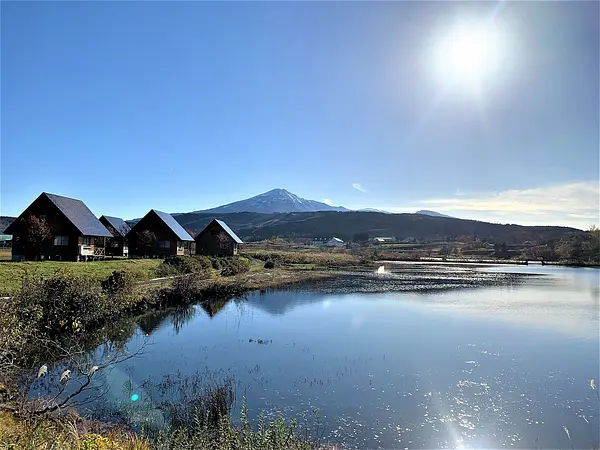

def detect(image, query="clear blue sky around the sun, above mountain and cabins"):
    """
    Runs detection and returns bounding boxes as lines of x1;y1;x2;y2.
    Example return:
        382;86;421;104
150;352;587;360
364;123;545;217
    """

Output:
0;2;600;228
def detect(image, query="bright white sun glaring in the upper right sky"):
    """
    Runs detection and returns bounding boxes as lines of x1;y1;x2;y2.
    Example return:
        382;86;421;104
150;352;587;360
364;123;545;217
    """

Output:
433;24;504;93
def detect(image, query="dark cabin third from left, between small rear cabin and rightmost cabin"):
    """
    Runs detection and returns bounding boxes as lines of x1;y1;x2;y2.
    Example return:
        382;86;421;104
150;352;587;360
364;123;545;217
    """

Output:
126;209;195;257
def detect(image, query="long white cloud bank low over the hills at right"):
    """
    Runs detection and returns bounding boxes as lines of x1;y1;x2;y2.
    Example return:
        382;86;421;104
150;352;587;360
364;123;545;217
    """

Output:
372;181;600;229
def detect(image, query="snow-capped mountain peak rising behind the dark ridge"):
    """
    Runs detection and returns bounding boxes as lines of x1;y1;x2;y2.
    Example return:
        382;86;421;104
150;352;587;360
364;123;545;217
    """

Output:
194;189;349;214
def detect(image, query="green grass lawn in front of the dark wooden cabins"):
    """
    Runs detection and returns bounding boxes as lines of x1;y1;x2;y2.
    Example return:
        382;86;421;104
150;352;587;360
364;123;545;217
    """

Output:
0;259;162;296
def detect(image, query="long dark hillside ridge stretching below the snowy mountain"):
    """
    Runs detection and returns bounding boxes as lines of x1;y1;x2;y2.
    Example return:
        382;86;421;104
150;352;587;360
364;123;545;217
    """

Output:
176;211;581;243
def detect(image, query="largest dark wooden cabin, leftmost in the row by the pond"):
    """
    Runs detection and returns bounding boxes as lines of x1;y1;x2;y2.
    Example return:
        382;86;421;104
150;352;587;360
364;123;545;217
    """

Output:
4;192;112;261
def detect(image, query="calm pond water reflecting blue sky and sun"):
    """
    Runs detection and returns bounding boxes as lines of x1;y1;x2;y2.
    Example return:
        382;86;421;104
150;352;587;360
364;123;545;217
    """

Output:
86;264;600;448
